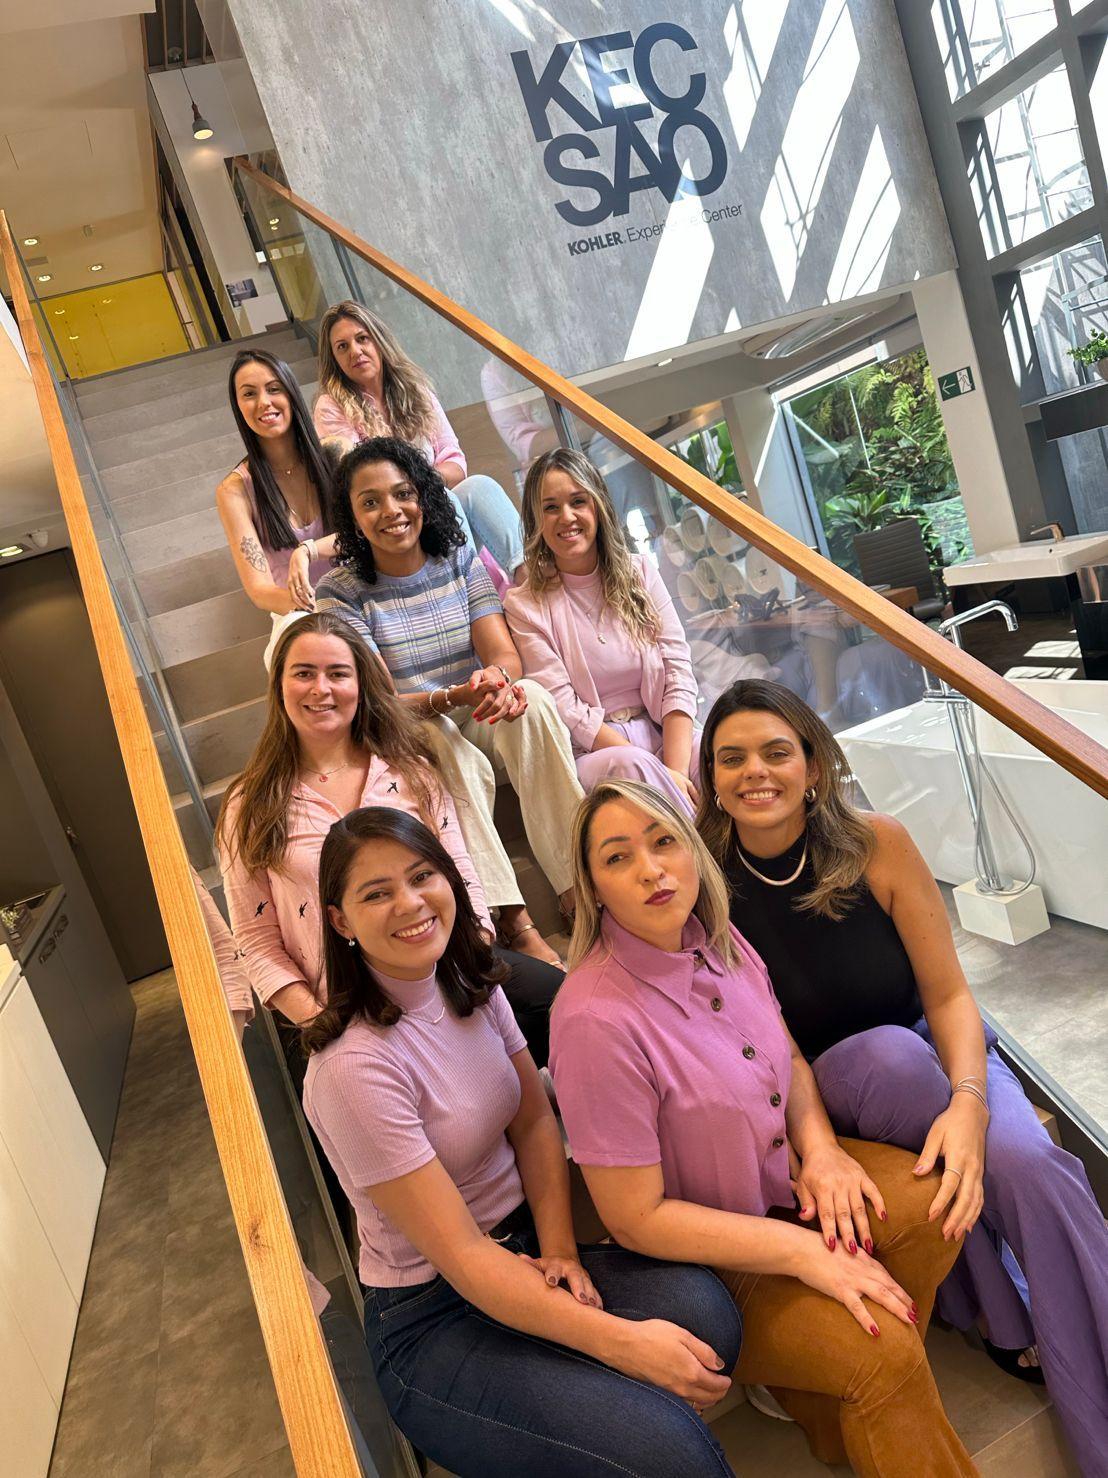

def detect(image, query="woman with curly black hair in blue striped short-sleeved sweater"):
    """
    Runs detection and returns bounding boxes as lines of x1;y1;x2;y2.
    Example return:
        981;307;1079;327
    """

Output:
316;436;584;961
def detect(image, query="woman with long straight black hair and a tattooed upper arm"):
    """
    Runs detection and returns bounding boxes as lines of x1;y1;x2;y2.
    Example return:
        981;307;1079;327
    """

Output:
216;349;335;665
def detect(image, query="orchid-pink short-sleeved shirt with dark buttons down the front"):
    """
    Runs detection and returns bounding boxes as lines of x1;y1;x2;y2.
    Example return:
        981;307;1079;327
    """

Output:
550;913;793;1216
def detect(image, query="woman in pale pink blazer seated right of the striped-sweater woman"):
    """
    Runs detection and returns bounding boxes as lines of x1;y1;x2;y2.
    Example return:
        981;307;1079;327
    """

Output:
504;446;699;813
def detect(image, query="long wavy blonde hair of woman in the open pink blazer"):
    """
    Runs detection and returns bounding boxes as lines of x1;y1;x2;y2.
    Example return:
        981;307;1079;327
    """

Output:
523;446;662;646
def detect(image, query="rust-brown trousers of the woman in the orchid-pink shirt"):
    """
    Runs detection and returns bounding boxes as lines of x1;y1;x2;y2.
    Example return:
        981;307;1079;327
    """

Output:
719;1140;977;1478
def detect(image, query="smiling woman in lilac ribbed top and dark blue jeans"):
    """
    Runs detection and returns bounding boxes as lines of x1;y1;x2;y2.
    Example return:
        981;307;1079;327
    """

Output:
304;807;742;1478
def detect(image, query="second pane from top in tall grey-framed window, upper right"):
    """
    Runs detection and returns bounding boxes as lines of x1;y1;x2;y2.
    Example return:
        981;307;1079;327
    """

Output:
968;67;1093;256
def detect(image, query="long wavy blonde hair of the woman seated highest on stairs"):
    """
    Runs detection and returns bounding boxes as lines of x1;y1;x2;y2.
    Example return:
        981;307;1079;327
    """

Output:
319;299;436;442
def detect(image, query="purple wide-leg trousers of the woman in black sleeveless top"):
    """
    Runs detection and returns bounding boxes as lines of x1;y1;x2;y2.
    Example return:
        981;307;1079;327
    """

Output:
813;1021;1108;1478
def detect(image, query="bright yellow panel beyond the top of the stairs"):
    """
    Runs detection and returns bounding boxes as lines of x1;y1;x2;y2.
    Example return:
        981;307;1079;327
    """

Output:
43;272;189;380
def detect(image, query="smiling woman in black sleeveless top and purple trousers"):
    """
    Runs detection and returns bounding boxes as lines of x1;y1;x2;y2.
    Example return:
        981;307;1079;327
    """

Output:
697;678;1108;1472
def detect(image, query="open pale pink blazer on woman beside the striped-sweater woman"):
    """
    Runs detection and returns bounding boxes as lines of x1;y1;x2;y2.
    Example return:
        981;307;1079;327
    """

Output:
504;554;697;754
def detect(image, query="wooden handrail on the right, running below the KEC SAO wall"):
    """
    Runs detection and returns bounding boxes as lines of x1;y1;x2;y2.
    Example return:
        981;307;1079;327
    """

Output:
235;157;1108;797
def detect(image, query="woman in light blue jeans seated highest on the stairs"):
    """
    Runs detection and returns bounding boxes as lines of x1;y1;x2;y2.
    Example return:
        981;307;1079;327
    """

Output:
312;299;523;578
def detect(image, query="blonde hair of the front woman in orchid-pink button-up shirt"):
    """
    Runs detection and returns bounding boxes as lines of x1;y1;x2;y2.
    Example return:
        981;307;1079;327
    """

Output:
569;780;736;970
